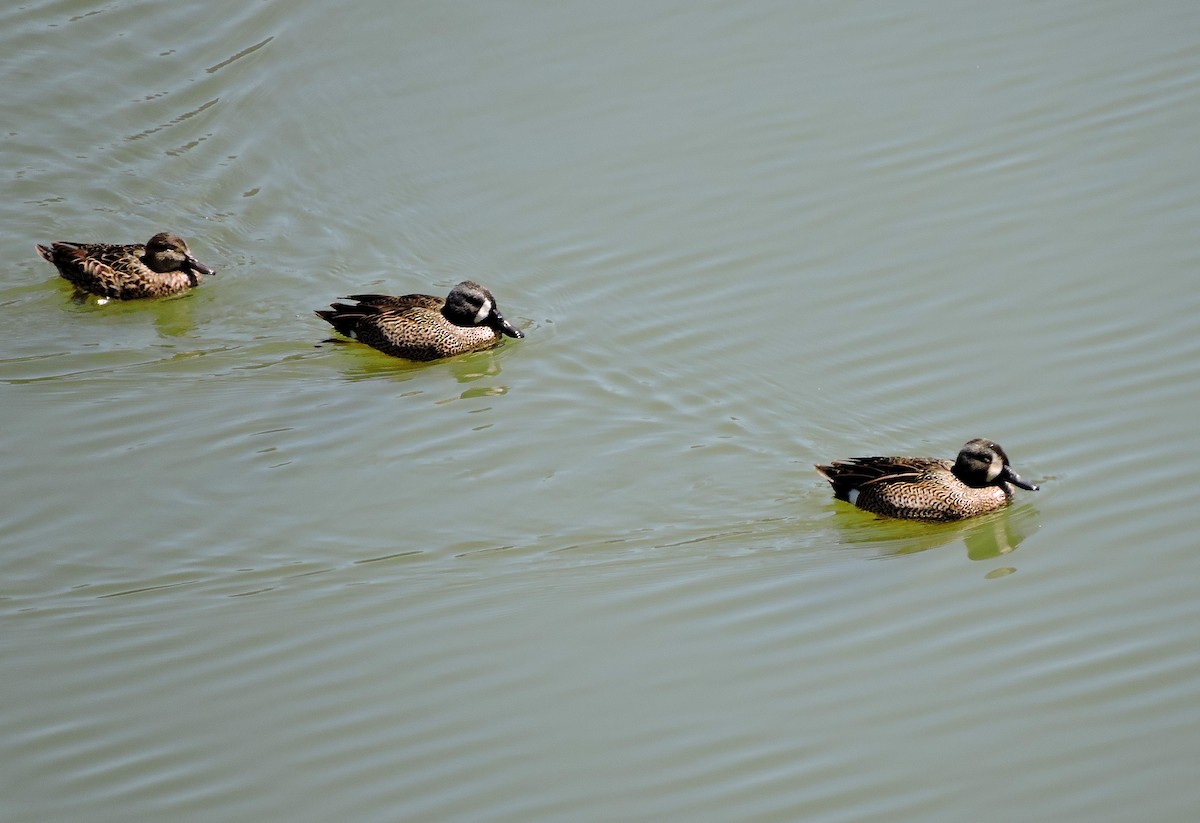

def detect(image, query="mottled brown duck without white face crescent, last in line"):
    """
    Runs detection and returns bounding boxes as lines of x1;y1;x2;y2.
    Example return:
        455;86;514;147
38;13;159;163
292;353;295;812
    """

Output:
37;232;216;300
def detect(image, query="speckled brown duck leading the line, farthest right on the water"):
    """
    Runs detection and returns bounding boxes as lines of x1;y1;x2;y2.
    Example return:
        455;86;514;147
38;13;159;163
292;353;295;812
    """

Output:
816;439;1038;521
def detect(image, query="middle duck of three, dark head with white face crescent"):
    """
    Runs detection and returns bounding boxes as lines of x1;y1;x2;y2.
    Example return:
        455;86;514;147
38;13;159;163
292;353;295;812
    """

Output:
317;280;524;360
